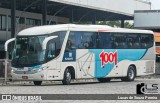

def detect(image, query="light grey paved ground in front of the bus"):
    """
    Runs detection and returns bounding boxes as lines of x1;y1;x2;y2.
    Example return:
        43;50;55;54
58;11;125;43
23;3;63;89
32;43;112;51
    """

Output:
0;78;160;103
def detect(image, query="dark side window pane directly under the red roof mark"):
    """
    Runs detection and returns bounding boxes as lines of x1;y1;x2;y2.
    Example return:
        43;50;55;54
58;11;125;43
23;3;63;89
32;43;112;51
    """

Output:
98;32;113;49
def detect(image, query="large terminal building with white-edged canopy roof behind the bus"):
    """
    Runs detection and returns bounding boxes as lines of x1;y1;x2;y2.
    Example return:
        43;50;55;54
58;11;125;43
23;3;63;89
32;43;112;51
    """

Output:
0;0;151;59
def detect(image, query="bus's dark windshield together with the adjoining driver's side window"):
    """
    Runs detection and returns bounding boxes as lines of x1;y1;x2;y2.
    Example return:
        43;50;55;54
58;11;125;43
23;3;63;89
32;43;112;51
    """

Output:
12;31;66;68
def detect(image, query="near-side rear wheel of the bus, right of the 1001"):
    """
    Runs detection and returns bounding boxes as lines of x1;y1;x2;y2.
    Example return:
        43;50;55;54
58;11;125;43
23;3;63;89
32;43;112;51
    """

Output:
121;65;136;81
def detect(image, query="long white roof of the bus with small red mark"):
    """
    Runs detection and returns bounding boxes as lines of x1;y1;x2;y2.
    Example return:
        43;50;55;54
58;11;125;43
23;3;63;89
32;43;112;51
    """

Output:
17;24;153;36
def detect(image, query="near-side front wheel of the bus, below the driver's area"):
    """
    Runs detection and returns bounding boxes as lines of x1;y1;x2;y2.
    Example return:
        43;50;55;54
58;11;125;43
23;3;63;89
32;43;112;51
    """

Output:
62;69;72;85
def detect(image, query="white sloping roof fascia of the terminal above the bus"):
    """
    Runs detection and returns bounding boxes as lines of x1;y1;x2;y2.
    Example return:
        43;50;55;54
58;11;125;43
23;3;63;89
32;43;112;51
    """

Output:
49;0;151;16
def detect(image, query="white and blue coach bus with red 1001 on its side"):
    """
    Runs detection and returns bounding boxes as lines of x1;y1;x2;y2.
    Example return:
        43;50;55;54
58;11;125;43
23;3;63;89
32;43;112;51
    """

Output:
7;24;155;85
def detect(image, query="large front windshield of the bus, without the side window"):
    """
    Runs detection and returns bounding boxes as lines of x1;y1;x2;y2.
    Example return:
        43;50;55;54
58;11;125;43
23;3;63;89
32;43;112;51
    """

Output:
12;36;45;67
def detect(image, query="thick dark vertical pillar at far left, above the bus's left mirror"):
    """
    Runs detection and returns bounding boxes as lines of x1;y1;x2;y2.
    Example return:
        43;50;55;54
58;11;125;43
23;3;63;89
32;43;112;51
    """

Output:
11;0;16;38
